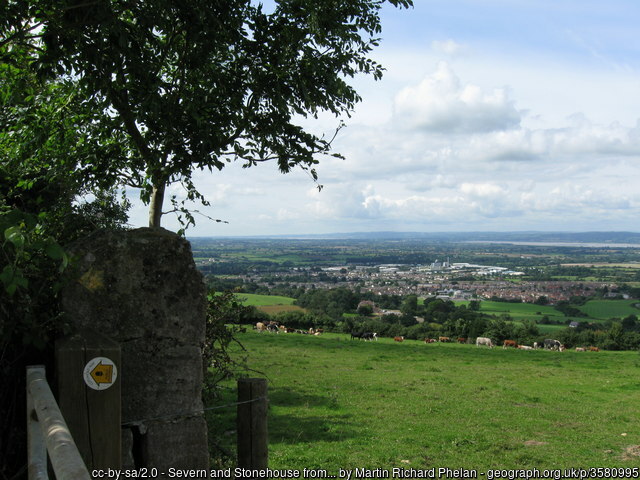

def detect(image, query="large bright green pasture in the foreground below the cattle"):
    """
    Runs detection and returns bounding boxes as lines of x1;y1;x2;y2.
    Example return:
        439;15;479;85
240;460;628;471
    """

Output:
210;331;640;474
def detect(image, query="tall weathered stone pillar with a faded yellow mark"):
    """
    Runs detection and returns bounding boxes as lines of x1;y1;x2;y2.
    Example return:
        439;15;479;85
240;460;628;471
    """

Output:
62;228;209;473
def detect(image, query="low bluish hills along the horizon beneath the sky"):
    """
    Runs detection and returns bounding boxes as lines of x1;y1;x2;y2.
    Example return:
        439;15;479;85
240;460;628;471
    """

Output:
195;231;640;242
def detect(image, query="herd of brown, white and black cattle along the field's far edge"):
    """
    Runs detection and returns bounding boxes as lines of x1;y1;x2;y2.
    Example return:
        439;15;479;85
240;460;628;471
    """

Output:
251;322;600;352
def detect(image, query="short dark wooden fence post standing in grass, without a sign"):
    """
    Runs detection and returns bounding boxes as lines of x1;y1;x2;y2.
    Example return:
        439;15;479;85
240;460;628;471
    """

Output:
237;378;269;470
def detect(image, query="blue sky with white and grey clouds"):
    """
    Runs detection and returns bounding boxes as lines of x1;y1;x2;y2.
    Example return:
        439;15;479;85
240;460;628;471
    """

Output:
130;0;640;236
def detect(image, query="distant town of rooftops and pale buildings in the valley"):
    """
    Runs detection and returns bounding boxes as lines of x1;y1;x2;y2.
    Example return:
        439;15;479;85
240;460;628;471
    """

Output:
197;240;640;304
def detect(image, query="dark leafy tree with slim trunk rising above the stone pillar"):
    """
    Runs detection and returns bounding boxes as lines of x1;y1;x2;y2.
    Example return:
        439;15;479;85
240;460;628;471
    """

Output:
0;0;413;226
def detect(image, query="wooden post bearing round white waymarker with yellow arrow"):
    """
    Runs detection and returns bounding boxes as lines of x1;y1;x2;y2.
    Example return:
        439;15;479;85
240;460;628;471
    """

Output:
56;330;123;470
